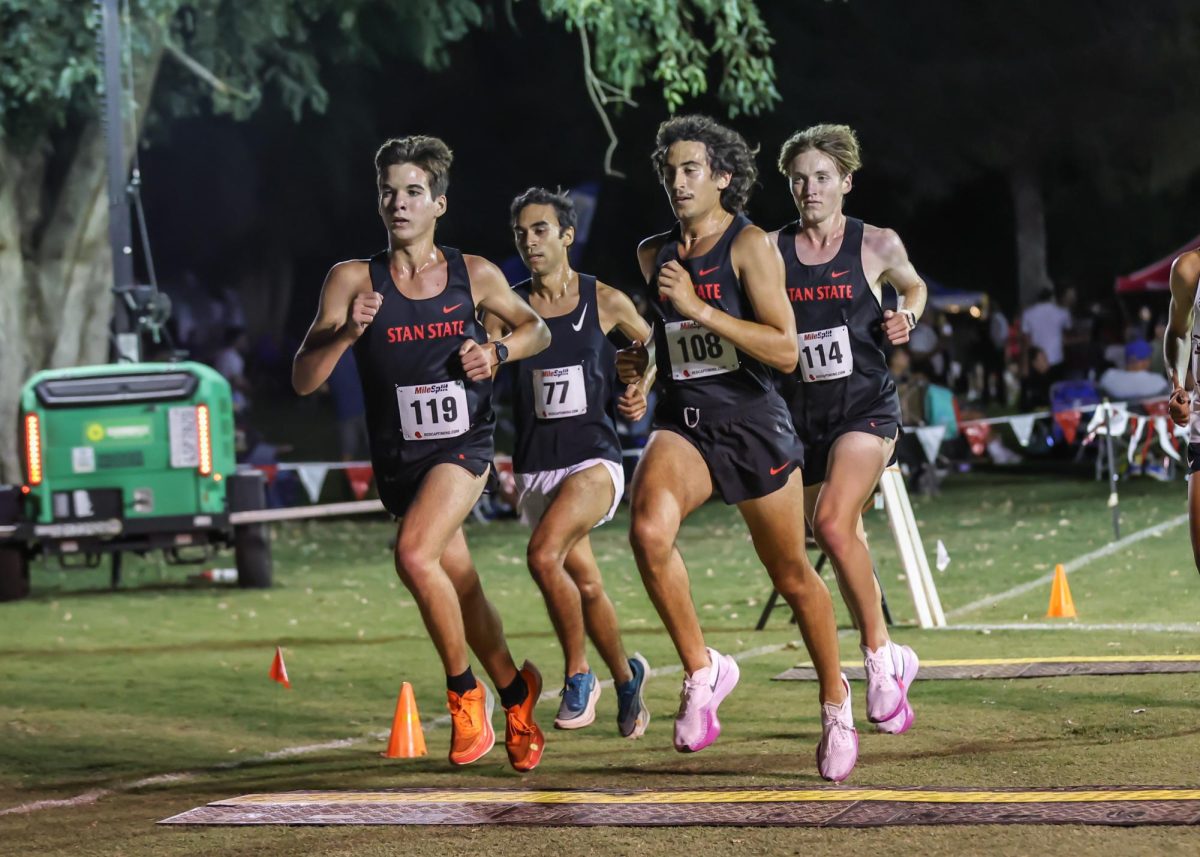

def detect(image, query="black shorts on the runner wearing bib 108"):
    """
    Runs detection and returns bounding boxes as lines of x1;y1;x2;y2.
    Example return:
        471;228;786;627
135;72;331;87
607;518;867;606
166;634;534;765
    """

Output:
653;391;804;505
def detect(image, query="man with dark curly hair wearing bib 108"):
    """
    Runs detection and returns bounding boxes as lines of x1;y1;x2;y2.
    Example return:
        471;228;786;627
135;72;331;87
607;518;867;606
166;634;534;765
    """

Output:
618;116;858;781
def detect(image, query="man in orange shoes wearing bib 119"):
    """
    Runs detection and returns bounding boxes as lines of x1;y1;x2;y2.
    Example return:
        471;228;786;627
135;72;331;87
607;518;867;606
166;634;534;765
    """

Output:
292;137;550;771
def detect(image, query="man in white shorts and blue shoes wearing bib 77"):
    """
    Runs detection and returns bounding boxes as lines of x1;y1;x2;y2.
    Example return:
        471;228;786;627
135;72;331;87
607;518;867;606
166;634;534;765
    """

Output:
486;187;654;738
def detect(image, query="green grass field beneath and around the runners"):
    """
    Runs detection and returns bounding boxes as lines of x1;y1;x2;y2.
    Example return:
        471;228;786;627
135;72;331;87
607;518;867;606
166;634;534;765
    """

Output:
0;474;1200;856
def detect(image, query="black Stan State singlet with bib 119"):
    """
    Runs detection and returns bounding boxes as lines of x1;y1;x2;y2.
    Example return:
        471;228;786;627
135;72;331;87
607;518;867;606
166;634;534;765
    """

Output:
354;247;496;467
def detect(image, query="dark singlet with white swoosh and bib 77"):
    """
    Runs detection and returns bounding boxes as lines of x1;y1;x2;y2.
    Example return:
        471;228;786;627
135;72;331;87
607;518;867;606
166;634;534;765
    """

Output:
512;274;620;473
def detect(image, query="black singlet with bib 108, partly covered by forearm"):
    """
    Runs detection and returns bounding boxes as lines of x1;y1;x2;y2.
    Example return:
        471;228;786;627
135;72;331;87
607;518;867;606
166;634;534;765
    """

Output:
648;214;772;414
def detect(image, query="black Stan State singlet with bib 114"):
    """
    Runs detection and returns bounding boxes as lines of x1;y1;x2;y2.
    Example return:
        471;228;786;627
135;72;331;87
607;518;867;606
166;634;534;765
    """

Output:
779;217;899;424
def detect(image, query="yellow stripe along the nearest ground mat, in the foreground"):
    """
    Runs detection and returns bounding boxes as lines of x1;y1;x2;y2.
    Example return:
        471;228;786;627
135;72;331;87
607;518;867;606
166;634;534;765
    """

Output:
223;789;1200;807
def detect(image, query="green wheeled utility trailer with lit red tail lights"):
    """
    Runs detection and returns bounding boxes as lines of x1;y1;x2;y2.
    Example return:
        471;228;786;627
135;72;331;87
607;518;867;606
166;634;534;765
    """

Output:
0;362;271;601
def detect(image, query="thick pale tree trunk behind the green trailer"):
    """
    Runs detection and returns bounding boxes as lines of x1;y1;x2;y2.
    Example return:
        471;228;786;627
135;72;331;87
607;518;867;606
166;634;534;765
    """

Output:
0;48;162;484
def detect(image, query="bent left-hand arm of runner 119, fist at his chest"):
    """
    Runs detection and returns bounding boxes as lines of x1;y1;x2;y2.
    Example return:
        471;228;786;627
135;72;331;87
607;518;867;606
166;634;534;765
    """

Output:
292;262;369;396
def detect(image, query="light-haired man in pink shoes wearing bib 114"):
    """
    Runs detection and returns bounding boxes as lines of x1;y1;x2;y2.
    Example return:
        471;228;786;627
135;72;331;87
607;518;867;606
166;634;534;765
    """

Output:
774;125;925;733
